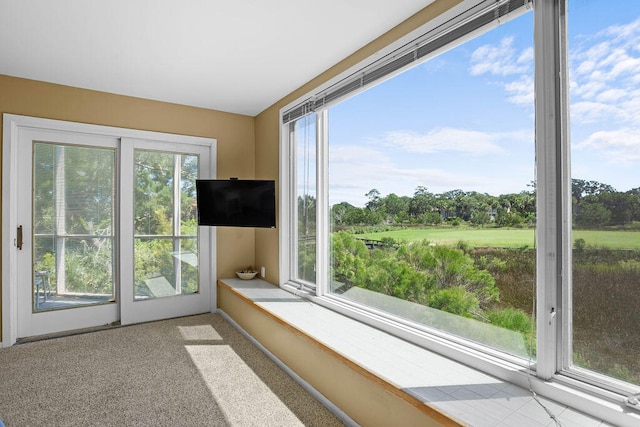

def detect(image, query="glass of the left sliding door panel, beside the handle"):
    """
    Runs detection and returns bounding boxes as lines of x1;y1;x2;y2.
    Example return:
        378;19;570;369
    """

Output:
33;142;115;311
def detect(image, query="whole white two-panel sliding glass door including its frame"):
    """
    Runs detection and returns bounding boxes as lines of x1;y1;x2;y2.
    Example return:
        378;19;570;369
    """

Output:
3;116;215;343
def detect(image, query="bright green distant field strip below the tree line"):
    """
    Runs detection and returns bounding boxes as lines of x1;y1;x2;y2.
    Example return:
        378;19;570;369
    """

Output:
356;227;640;250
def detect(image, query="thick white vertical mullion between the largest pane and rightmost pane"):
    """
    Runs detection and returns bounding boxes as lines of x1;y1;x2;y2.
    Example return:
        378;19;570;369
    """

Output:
534;0;571;379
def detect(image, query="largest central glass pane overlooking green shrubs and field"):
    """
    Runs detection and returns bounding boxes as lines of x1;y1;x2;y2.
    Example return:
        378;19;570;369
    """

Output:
328;13;536;359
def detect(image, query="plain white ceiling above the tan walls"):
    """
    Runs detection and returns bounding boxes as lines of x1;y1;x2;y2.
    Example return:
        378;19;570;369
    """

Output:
0;0;433;116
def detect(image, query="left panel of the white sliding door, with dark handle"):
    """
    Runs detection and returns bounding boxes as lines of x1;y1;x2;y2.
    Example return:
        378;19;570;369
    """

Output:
17;130;119;337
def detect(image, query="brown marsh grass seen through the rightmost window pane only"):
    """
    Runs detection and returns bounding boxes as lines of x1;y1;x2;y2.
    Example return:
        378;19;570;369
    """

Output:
573;248;640;384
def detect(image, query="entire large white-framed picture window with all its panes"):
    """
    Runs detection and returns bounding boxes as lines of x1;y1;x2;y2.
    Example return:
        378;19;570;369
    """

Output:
282;0;640;422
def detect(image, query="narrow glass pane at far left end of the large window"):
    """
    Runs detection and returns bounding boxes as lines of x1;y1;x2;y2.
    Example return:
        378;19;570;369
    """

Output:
291;114;316;286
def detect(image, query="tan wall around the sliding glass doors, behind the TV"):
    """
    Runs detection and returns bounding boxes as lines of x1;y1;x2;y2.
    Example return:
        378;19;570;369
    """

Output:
0;75;255;340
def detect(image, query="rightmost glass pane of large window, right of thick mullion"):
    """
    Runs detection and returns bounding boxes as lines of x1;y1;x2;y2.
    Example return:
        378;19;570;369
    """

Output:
568;0;640;384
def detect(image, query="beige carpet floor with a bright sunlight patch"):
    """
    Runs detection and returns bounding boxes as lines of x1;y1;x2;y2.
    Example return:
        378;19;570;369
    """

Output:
0;314;342;427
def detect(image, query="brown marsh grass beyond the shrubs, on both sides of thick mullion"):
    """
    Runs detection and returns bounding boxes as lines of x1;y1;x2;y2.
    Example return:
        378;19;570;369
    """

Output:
469;246;640;384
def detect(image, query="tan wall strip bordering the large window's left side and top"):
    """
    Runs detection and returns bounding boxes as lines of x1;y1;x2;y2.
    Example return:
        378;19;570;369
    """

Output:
255;0;462;284
